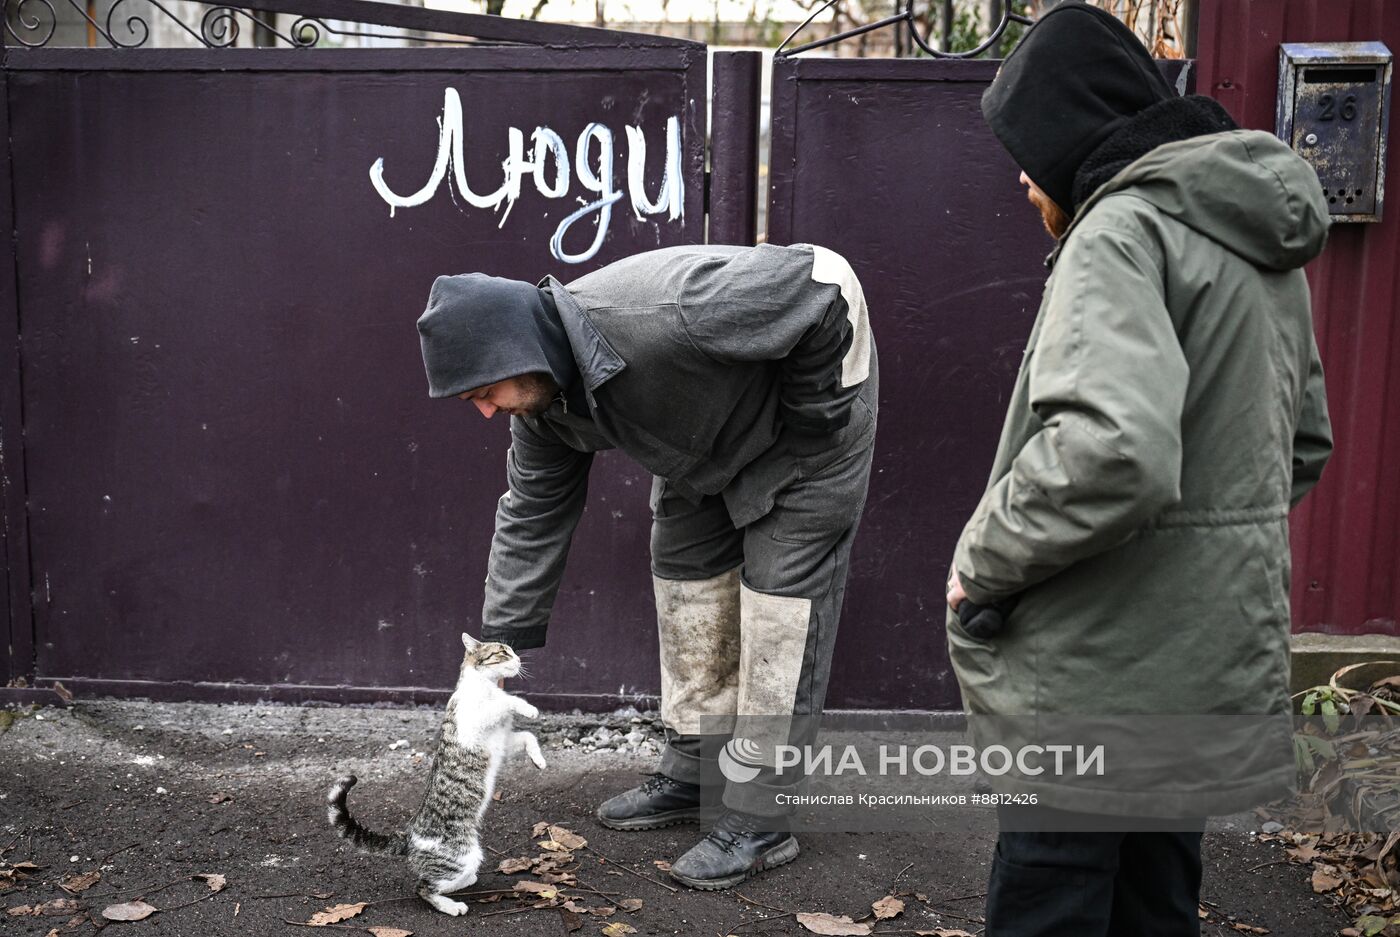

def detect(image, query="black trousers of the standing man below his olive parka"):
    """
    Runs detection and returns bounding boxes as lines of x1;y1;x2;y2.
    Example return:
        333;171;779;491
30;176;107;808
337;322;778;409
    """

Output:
986;811;1203;937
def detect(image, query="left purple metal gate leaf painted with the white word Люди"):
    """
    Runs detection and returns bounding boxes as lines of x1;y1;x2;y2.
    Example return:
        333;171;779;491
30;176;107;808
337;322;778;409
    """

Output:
0;0;722;702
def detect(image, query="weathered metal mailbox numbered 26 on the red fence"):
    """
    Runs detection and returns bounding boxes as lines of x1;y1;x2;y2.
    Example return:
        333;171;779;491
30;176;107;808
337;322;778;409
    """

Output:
1275;42;1392;221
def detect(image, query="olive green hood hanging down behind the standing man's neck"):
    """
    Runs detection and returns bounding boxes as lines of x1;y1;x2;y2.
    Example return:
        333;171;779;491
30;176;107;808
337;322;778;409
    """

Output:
1075;130;1331;270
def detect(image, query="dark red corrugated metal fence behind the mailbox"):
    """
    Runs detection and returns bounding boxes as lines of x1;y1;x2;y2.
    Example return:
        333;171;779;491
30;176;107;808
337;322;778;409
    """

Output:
1196;0;1400;634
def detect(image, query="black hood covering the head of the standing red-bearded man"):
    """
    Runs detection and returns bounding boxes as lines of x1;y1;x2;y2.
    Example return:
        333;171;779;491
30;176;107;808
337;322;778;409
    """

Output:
981;3;1176;214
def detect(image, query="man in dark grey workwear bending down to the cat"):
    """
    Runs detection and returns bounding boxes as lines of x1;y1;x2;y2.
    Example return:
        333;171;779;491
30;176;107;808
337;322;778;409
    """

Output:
419;239;879;889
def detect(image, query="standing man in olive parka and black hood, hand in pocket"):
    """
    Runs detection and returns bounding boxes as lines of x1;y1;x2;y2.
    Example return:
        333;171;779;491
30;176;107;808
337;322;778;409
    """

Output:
948;3;1331;937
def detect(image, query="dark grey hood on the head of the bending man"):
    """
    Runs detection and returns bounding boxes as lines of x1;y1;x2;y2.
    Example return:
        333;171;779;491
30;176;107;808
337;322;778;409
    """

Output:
419;273;577;398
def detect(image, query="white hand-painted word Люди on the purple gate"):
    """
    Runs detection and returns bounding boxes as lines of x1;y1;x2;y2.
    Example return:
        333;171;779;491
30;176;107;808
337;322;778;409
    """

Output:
370;88;685;263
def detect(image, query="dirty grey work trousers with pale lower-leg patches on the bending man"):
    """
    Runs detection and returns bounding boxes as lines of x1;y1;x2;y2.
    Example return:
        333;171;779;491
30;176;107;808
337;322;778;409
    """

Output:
651;381;875;817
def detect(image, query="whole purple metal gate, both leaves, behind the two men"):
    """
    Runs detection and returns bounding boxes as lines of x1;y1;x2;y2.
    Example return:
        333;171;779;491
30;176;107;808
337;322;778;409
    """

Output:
0;0;1237;709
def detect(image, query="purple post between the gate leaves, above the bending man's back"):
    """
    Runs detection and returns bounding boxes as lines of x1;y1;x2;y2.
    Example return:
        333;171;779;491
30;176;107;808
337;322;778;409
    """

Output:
706;52;763;247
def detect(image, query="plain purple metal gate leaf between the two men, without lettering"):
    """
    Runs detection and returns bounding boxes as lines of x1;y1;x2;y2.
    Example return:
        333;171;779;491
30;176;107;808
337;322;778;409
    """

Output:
769;59;1051;709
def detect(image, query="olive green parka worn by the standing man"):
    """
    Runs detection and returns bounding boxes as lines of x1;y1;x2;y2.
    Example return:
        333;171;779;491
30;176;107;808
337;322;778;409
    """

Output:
948;130;1331;815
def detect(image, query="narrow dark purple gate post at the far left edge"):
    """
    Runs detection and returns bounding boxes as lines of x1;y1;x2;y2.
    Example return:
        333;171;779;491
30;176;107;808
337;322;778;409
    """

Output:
0;34;36;688
